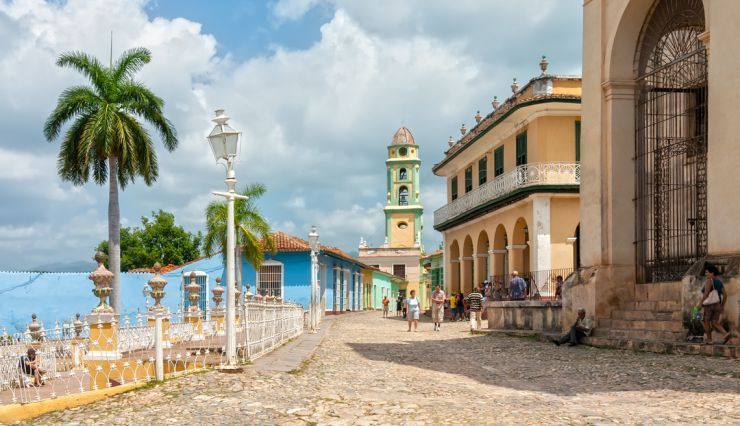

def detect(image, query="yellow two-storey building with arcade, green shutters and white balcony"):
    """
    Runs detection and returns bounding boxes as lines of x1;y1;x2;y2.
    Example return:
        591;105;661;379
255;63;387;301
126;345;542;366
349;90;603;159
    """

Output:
433;61;581;297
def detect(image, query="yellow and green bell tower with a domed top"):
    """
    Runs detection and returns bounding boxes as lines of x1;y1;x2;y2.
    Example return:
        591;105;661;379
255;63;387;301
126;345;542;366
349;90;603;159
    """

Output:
383;127;424;248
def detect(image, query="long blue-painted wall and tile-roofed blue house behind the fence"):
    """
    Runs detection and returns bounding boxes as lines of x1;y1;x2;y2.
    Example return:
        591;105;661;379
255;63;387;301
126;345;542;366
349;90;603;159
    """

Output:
0;232;364;333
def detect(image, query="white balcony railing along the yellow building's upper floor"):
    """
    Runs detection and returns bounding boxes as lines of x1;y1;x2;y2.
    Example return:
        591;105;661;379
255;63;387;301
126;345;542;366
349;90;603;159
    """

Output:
434;163;581;226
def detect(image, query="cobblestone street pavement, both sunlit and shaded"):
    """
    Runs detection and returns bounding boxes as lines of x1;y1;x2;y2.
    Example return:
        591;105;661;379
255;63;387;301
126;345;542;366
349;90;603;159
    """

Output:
20;312;740;425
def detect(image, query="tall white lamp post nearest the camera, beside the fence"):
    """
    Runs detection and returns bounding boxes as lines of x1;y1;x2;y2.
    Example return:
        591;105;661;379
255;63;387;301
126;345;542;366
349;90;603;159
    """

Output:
208;109;247;366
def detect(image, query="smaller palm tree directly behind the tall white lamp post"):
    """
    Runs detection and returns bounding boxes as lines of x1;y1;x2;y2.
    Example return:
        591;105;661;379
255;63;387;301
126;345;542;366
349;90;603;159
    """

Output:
203;183;275;285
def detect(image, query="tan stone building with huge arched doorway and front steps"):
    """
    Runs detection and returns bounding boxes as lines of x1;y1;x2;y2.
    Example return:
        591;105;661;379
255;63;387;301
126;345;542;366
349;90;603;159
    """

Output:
580;0;740;352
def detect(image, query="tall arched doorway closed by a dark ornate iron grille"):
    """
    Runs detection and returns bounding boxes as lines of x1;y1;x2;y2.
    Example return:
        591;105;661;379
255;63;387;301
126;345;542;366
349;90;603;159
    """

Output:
635;0;708;283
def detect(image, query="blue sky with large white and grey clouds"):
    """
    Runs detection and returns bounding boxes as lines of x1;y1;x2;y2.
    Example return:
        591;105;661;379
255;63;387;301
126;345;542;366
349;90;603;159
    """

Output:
0;0;582;270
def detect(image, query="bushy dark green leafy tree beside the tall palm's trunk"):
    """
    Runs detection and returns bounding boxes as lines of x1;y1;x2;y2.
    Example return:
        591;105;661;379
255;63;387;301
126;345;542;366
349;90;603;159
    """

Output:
97;210;203;271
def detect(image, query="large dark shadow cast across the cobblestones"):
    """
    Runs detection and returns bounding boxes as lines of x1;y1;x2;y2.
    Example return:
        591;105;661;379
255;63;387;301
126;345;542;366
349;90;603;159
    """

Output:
347;330;740;395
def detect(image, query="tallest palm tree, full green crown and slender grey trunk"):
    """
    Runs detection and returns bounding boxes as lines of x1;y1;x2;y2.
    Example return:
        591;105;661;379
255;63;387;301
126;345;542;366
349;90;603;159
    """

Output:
44;48;177;312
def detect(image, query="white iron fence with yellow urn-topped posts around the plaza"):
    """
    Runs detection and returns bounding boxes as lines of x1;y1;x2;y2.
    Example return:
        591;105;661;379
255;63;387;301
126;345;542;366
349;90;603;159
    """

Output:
0;297;304;405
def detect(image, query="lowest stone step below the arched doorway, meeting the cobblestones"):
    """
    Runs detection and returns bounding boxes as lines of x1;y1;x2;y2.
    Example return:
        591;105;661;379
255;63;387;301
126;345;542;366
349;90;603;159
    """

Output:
583;336;740;359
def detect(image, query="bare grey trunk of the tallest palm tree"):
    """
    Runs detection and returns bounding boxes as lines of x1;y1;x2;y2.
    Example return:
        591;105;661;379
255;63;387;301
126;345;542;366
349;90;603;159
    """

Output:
108;156;121;315
